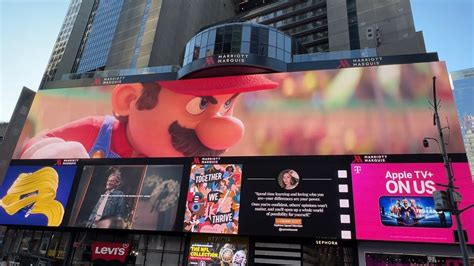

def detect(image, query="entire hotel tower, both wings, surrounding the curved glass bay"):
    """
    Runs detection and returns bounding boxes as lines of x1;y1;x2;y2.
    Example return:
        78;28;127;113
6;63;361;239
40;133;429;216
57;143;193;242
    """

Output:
42;0;425;87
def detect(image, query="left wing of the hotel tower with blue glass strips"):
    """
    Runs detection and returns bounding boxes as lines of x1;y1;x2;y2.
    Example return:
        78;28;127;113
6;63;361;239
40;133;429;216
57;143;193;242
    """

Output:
42;0;238;84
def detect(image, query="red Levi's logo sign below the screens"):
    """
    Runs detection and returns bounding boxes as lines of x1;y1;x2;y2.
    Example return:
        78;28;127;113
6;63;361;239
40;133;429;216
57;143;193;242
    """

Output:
92;242;130;262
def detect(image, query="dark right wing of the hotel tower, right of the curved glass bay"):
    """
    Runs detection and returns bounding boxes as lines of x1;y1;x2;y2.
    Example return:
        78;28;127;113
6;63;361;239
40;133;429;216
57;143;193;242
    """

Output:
241;0;426;55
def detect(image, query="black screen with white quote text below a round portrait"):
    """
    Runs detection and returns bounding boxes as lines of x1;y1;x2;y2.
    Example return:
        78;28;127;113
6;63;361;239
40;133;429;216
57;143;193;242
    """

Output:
239;156;355;240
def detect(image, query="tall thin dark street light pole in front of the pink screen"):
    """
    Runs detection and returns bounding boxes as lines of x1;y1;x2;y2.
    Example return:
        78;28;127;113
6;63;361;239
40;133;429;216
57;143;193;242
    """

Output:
433;77;469;266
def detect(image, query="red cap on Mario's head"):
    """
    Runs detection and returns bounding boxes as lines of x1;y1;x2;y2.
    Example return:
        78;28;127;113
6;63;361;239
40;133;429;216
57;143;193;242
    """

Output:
158;75;278;96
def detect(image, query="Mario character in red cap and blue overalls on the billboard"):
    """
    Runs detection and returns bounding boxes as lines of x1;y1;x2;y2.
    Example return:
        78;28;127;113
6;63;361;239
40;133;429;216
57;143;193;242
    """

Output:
21;75;278;159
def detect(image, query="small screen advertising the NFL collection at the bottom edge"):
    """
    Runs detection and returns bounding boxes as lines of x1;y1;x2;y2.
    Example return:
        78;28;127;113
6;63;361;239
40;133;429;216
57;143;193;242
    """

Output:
188;235;249;266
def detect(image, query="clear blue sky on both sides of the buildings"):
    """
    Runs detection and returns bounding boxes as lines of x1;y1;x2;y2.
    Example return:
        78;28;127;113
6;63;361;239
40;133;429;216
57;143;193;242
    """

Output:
0;0;474;121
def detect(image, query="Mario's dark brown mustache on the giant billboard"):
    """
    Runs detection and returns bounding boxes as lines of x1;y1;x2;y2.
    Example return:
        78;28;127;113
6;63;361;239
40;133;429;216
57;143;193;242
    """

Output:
168;121;225;157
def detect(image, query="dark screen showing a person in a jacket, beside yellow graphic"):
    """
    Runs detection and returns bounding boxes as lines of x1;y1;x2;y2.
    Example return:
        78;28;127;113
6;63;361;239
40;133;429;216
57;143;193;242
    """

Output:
69;165;183;231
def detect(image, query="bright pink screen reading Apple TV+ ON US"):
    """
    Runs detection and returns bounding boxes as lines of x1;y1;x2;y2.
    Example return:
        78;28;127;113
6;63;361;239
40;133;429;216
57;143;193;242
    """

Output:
351;162;474;244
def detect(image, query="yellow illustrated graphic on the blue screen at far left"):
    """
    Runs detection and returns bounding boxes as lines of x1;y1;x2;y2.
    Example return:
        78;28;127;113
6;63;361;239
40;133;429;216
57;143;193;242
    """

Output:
0;167;64;226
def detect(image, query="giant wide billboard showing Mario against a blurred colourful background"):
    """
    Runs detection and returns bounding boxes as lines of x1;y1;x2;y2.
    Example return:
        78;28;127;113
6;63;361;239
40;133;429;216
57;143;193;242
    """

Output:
14;62;464;159
